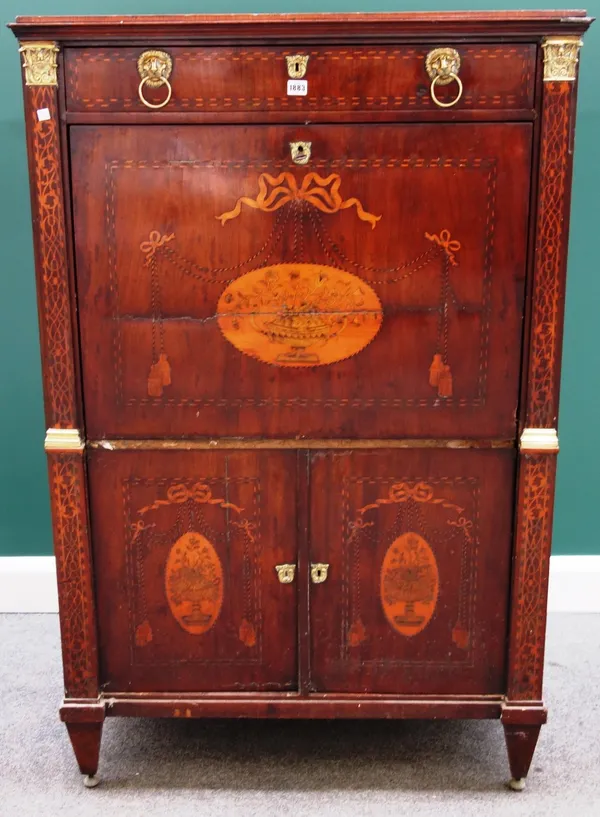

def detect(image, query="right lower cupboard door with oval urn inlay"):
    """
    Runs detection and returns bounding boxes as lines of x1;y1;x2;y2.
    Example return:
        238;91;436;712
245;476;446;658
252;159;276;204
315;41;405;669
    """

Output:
310;449;515;695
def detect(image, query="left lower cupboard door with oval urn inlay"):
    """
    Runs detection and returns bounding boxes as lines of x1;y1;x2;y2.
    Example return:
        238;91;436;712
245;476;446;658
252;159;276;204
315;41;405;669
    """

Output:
88;450;297;692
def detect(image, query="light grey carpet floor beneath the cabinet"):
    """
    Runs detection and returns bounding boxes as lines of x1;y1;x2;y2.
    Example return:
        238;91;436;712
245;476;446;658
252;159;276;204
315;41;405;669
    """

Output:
0;614;600;817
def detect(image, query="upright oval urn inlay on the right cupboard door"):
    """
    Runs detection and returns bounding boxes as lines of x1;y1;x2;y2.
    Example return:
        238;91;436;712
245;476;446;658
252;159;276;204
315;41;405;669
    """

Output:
380;532;439;636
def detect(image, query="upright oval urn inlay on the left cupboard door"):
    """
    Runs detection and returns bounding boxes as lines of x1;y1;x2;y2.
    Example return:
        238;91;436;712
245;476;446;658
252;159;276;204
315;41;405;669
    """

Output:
165;531;223;635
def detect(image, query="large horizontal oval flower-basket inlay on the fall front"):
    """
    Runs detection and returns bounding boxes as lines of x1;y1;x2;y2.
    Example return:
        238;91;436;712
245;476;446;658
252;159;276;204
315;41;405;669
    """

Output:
217;264;383;367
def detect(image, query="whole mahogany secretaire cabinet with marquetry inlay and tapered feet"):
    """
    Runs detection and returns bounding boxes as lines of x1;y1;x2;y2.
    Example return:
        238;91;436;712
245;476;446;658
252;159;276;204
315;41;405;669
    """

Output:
13;11;590;789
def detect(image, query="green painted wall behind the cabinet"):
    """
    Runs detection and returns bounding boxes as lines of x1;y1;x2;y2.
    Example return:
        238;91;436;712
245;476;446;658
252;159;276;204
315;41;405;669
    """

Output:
0;0;600;555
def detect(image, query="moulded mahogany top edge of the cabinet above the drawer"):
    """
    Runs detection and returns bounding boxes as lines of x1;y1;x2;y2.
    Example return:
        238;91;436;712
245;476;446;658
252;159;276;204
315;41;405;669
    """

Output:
8;9;593;42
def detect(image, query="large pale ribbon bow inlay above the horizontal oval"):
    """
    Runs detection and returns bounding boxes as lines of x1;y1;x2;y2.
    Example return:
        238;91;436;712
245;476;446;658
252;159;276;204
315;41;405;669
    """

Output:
216;173;381;229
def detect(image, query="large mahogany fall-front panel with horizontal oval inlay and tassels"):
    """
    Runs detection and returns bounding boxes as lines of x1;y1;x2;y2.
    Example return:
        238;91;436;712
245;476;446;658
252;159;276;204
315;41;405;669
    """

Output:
71;123;532;438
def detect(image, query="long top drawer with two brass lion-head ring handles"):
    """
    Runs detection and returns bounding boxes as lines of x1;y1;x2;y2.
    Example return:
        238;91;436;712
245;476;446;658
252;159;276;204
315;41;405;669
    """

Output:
65;43;536;113
